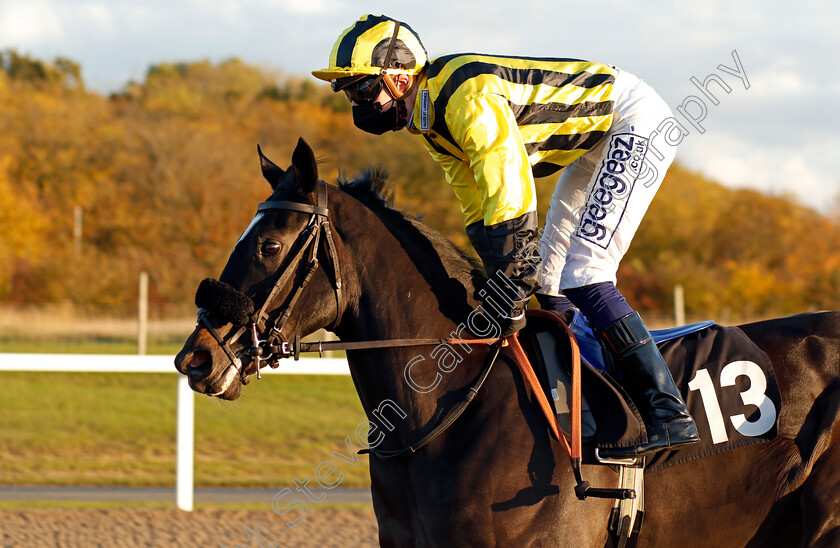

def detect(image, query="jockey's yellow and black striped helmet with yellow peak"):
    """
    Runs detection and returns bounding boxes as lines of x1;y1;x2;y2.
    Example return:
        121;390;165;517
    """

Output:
312;14;428;81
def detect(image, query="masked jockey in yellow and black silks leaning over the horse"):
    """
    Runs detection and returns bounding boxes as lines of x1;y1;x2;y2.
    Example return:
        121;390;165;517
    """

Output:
312;15;699;458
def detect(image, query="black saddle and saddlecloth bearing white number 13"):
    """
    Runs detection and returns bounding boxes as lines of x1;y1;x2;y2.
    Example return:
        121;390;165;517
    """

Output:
519;312;781;470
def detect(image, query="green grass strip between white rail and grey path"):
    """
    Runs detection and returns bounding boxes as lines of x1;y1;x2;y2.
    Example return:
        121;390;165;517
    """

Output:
0;372;369;487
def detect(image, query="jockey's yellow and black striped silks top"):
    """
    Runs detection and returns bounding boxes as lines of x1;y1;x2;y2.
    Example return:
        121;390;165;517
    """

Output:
409;54;618;226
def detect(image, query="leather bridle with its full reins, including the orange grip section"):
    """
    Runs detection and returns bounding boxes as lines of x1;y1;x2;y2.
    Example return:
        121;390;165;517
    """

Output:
198;185;629;499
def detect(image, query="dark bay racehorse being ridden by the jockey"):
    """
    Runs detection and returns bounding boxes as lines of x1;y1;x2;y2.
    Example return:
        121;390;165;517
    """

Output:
176;140;840;548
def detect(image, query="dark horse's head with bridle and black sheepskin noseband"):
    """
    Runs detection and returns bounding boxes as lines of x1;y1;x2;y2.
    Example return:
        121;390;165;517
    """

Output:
175;139;343;400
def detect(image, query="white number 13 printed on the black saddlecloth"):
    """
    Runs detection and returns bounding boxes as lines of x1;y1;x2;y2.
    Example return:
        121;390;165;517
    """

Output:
688;361;776;444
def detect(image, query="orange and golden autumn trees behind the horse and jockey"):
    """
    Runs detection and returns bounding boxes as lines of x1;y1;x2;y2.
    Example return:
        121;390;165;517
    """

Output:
0;52;840;314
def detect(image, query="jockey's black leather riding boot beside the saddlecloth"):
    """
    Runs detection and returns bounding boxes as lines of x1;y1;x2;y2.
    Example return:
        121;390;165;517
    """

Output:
599;312;700;458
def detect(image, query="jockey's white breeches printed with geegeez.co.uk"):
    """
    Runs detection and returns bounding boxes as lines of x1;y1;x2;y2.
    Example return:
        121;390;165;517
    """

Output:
540;71;676;295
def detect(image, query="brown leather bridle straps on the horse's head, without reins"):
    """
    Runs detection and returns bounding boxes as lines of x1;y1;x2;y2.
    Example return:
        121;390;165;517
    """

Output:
197;181;344;384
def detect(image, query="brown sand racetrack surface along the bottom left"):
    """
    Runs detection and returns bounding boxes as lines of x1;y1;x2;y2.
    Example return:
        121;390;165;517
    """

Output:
0;507;378;548
